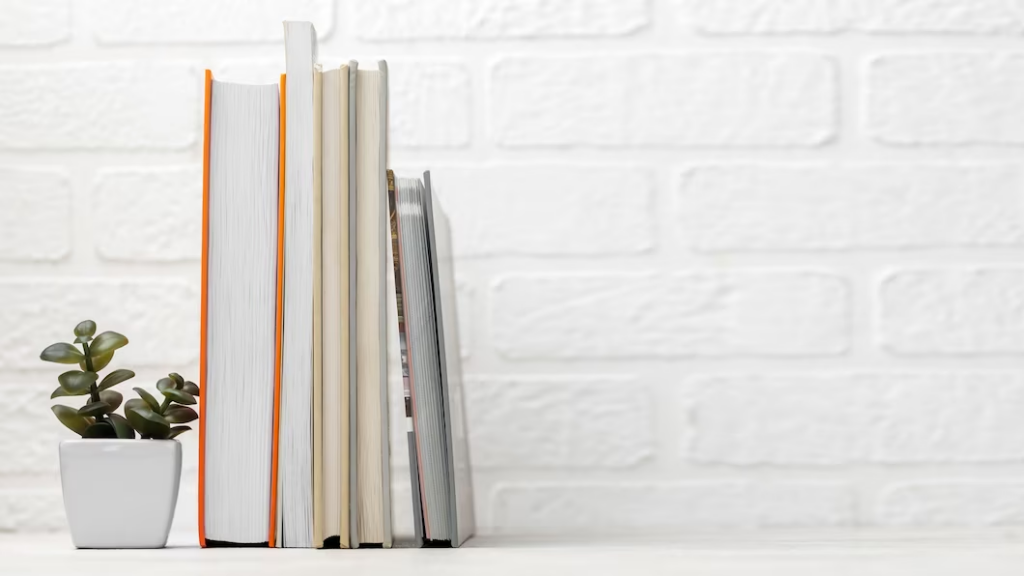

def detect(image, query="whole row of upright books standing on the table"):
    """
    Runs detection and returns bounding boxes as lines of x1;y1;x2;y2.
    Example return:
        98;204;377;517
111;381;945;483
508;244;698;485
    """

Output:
199;23;474;548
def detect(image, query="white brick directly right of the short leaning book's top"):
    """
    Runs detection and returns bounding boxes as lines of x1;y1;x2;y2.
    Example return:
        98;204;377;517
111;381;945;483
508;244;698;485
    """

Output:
432;165;654;256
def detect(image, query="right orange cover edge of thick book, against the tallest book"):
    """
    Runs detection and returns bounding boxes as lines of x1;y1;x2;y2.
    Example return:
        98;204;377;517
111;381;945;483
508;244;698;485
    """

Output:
267;74;286;548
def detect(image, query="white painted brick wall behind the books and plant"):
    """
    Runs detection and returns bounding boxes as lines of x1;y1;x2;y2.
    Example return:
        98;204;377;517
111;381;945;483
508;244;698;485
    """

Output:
0;0;1024;534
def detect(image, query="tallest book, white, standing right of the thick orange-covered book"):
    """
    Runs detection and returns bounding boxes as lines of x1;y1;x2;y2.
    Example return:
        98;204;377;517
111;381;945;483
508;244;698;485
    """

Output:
276;22;316;547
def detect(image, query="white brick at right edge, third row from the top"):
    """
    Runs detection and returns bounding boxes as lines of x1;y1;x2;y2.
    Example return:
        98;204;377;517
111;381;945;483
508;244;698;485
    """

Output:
676;164;1024;251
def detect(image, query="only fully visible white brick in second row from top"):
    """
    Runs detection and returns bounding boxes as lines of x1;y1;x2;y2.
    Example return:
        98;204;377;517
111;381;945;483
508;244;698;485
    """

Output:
490;53;838;147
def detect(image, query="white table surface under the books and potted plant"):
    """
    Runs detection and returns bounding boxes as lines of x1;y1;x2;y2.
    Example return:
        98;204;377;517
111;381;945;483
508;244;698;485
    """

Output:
8;530;1024;576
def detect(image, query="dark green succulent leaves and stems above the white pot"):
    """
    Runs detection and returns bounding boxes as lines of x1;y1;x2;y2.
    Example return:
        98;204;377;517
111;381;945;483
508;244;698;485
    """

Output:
39;320;199;440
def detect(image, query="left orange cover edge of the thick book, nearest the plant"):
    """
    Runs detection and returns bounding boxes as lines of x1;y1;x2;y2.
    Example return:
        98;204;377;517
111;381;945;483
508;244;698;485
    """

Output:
199;70;213;548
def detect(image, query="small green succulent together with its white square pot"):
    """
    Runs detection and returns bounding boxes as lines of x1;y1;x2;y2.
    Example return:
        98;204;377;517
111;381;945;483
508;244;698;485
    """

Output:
40;320;199;548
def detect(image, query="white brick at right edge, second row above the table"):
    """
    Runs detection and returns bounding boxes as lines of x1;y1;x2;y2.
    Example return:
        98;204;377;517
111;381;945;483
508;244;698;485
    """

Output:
683;373;1024;465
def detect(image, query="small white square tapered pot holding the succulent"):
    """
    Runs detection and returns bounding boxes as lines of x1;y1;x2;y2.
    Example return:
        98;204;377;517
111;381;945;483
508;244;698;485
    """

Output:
60;439;181;548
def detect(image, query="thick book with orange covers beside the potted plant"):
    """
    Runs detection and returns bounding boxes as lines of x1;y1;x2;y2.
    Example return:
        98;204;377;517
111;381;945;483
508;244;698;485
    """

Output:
199;71;282;546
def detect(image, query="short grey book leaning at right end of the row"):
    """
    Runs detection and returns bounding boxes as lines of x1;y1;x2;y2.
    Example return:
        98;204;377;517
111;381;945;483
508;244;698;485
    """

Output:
389;172;475;546
